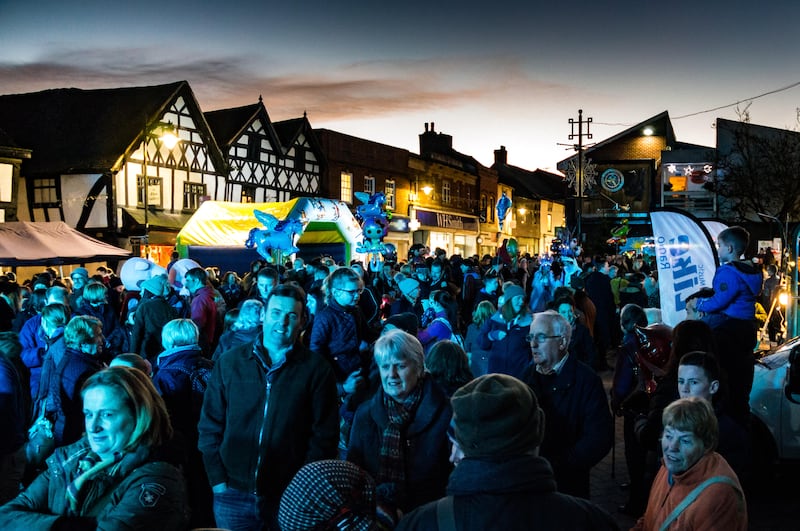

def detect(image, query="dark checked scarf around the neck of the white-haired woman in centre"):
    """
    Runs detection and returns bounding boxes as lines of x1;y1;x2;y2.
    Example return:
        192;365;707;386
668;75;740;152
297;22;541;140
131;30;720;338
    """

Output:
377;380;423;490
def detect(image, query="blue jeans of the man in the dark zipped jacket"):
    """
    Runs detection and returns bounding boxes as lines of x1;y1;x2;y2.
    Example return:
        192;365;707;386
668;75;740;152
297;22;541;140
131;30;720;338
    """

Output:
214;488;279;531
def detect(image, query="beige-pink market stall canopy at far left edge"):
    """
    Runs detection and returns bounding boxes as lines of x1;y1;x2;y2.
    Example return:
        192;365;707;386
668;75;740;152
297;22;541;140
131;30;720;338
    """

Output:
0;221;131;267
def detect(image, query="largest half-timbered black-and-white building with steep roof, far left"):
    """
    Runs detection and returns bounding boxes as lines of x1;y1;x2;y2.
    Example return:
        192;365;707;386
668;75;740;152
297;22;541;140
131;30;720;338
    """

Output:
0;81;226;246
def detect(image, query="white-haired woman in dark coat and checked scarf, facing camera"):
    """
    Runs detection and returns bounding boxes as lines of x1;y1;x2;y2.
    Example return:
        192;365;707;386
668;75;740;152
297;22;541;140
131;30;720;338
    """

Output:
347;330;452;513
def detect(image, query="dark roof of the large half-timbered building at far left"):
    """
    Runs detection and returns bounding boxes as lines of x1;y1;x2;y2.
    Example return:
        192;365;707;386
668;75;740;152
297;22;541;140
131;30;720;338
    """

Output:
0;81;223;174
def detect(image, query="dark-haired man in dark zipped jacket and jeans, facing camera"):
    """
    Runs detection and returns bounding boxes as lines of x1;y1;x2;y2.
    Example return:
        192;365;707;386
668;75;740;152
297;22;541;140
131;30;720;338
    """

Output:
198;285;339;531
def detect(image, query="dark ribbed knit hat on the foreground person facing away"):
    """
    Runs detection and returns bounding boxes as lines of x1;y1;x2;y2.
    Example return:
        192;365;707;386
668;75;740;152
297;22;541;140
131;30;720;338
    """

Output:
451;374;544;457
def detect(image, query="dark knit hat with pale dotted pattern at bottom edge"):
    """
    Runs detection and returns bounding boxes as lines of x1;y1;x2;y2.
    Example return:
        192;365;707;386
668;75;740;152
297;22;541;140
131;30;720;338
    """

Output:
278;459;376;531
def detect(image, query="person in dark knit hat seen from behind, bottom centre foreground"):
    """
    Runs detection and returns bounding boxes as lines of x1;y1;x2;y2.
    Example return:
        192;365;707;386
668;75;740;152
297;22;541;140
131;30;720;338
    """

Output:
397;374;618;531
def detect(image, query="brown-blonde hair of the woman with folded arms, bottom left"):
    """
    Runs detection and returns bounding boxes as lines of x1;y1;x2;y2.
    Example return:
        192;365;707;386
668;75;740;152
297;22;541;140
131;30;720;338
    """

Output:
81;366;172;450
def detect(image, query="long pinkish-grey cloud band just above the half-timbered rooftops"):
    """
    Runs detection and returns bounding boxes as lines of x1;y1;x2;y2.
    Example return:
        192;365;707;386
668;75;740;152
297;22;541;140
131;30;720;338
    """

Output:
0;48;570;120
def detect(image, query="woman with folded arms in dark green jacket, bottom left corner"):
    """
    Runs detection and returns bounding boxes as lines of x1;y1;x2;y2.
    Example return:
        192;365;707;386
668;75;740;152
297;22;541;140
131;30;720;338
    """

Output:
0;367;188;530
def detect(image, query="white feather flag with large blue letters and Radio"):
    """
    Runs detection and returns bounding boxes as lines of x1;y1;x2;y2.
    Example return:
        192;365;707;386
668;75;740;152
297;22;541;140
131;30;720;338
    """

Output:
650;209;717;326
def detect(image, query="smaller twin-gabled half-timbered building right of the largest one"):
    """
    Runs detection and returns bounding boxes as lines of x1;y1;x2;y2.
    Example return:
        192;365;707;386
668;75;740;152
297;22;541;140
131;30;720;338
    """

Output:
205;98;321;203
